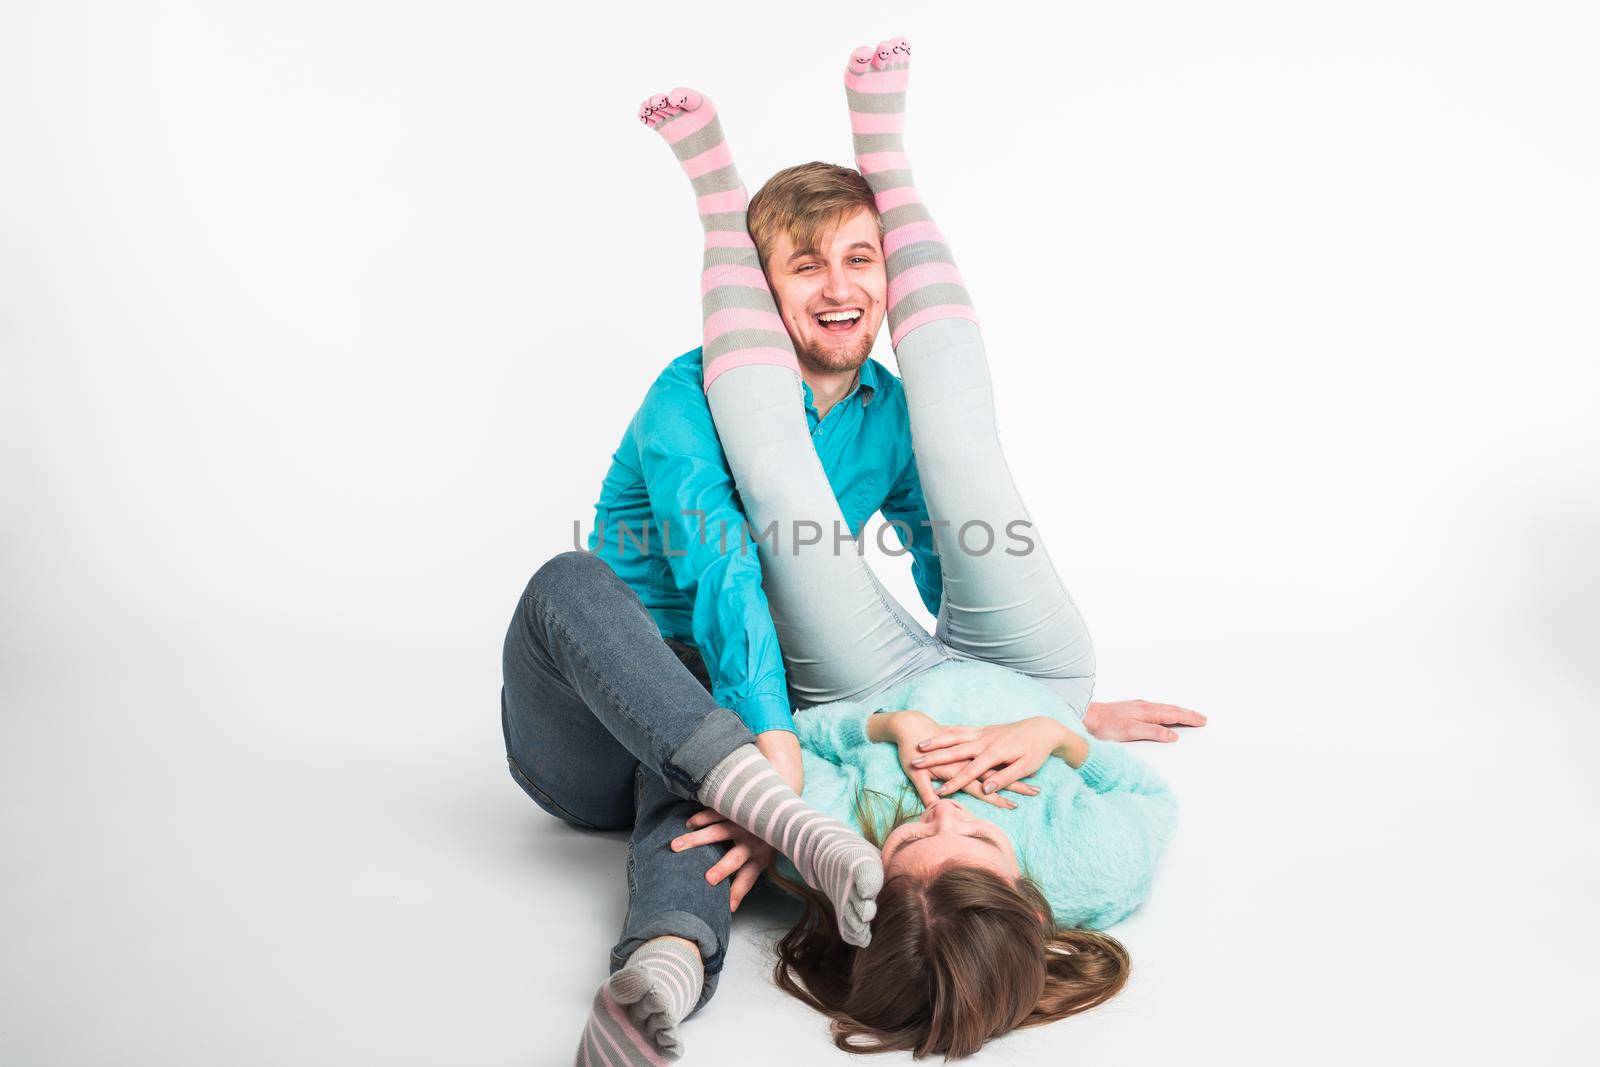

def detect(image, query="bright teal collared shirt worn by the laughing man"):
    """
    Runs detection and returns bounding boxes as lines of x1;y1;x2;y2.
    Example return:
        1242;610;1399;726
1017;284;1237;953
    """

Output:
589;349;942;733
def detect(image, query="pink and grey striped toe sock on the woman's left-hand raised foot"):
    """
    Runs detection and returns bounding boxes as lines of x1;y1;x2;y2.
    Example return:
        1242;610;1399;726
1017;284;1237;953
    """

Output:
638;88;800;390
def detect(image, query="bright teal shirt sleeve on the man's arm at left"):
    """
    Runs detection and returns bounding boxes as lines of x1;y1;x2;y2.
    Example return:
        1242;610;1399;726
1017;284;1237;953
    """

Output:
637;379;794;733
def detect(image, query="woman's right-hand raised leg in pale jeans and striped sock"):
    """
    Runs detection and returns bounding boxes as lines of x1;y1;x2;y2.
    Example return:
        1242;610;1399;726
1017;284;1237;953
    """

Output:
845;37;1094;715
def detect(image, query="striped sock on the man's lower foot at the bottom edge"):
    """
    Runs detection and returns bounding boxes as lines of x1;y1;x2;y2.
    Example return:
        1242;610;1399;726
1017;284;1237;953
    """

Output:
576;937;706;1067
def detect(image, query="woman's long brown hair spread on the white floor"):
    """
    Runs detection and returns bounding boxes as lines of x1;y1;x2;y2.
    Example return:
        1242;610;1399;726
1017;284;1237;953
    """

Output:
773;795;1128;1059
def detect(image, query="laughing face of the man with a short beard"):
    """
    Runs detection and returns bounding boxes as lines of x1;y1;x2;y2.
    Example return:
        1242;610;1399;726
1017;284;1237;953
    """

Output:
766;208;888;373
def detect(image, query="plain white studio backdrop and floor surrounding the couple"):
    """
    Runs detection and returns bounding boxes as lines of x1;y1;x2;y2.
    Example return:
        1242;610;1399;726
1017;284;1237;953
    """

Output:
0;0;1600;1067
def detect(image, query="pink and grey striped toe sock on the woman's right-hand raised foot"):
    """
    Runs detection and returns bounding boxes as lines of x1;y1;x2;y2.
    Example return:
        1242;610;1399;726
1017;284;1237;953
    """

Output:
845;37;978;350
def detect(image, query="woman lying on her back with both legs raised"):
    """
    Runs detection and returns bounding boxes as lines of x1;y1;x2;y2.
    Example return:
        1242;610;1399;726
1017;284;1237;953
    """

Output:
640;38;1176;1056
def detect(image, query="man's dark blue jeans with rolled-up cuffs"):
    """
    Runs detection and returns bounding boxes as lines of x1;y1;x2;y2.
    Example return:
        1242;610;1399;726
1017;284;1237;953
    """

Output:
501;552;755;1008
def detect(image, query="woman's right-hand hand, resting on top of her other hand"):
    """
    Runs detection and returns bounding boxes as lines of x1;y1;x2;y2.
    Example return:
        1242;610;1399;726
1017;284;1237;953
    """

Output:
910;715;1088;797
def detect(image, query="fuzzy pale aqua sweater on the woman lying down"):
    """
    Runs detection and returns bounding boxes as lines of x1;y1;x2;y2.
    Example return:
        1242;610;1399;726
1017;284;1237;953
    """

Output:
787;661;1178;929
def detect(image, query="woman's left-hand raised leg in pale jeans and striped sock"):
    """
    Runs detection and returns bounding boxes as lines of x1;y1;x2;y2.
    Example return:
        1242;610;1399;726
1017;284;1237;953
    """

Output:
640;90;946;705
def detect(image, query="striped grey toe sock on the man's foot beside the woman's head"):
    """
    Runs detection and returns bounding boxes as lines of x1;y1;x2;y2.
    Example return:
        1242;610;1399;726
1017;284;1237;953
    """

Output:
698;744;883;945
